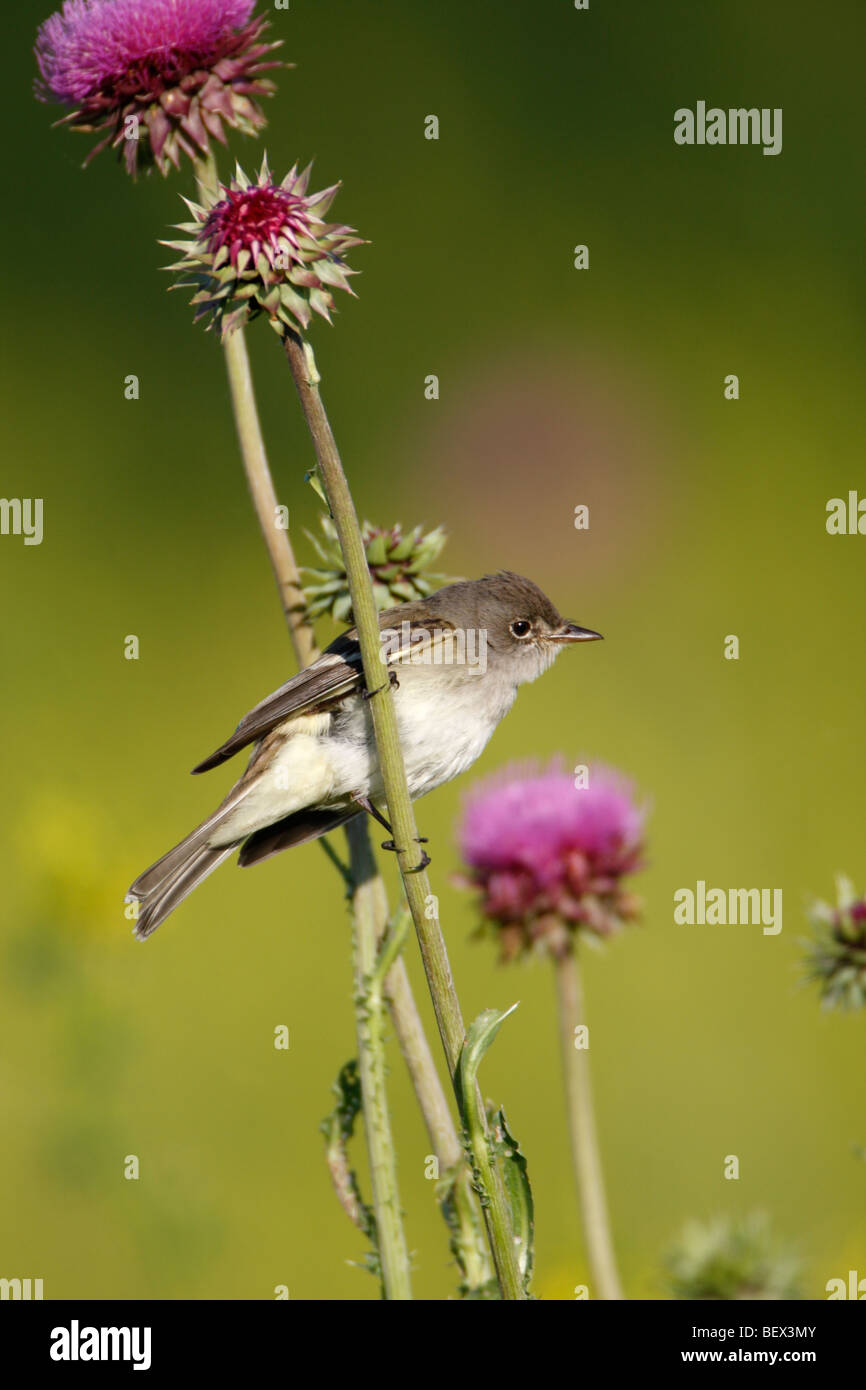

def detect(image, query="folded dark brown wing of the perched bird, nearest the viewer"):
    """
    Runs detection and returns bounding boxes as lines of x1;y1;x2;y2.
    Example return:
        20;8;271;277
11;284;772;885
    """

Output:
193;603;453;773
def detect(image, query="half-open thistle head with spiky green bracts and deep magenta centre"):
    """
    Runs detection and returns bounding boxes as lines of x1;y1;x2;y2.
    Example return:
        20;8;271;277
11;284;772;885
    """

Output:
164;158;363;338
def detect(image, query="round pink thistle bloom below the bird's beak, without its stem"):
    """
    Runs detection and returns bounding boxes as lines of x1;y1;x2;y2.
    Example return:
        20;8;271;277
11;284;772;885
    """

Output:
459;760;645;960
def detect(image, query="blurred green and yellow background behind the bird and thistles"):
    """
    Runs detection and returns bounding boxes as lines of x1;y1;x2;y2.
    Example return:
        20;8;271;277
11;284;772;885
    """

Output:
0;0;866;1300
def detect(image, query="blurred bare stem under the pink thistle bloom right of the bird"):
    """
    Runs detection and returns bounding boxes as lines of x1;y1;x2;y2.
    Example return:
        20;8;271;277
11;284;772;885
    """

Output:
555;951;623;1300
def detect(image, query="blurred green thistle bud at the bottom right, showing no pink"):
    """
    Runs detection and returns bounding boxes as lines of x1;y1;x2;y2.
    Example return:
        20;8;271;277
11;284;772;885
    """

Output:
664;1212;802;1300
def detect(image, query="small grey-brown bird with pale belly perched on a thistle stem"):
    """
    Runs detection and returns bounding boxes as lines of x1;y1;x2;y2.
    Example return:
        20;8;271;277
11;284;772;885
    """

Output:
126;571;601;941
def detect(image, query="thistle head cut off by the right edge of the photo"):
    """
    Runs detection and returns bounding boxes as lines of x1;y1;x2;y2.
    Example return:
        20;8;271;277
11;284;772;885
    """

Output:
806;874;866;1009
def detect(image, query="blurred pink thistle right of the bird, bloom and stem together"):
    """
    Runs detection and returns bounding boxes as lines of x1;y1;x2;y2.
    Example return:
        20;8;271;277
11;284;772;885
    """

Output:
459;762;644;1300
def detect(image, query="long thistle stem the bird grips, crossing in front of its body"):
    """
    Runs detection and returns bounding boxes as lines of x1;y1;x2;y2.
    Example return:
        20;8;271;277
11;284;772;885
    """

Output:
285;334;525;1300
